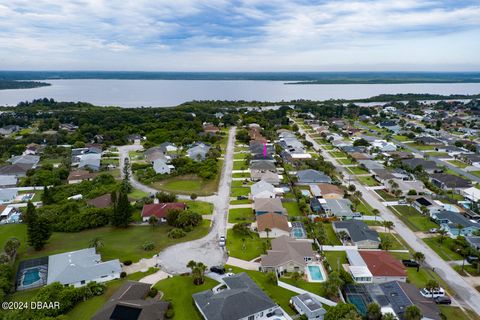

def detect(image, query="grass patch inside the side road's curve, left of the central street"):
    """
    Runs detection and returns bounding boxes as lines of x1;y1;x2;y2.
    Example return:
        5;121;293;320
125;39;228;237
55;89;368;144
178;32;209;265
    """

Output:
152;175;218;196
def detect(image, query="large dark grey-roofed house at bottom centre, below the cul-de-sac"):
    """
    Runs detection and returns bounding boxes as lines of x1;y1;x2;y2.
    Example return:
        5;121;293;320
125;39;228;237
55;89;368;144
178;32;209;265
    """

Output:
192;272;283;320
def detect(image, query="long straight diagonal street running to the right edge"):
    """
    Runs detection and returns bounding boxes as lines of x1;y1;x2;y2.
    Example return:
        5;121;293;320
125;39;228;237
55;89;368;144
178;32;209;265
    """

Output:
299;119;480;315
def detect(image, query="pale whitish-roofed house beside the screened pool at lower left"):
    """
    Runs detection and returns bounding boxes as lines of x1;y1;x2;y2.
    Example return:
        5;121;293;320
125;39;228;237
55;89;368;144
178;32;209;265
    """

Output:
47;248;122;287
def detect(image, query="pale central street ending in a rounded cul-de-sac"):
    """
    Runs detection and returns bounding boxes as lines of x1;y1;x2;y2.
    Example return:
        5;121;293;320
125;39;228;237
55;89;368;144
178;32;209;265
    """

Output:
159;127;236;274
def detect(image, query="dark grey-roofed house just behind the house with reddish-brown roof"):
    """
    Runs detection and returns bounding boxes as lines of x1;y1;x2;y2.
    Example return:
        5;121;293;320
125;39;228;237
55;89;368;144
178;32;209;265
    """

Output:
333;220;380;249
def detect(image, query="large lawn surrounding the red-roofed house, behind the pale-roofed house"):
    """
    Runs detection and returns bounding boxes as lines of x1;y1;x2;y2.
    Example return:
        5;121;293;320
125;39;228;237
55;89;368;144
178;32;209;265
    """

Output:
16;220;210;262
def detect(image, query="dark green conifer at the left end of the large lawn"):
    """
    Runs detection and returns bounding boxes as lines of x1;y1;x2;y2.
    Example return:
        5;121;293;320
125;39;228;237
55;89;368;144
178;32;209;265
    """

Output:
23;201;52;251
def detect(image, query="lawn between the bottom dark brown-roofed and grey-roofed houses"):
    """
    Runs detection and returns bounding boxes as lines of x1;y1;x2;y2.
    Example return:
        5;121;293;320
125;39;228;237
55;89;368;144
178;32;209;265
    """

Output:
155;276;218;320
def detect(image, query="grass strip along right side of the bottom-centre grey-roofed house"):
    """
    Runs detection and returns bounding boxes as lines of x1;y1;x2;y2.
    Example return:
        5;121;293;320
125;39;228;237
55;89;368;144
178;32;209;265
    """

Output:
225;265;298;315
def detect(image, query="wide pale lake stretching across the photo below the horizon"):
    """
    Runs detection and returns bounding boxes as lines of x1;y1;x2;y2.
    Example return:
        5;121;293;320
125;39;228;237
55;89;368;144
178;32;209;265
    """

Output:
0;79;480;107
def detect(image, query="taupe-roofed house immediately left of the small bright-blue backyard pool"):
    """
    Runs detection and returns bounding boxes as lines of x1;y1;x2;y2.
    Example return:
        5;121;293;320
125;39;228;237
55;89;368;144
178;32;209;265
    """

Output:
260;236;315;275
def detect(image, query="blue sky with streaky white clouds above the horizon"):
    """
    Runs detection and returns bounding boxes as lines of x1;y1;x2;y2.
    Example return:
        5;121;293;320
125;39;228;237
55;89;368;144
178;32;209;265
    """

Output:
0;0;480;71
